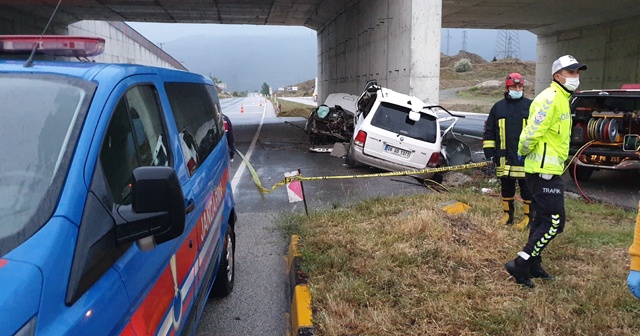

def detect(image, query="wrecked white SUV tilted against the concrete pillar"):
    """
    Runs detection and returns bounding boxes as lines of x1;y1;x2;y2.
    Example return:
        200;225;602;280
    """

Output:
345;81;471;177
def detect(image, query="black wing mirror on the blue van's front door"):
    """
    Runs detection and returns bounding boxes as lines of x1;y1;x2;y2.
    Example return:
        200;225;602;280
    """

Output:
116;167;185;250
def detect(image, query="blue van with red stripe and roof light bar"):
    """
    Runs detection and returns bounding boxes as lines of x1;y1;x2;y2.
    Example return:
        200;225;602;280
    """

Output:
0;36;236;336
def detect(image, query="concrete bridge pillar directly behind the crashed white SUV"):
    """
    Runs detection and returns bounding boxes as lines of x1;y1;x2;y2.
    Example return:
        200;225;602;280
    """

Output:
318;0;442;104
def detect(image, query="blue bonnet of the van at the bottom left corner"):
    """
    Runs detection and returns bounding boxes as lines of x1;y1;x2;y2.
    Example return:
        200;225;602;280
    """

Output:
0;259;42;335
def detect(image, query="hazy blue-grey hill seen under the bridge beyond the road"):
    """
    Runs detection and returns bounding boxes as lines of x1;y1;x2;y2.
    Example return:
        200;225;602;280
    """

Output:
164;35;317;92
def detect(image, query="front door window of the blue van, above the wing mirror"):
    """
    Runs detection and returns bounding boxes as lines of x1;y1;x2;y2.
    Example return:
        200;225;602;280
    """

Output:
100;86;170;204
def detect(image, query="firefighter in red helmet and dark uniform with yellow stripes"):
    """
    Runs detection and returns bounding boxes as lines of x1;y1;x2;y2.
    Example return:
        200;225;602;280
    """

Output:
482;72;532;229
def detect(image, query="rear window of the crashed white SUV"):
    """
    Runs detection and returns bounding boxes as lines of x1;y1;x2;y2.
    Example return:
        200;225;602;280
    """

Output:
371;103;438;143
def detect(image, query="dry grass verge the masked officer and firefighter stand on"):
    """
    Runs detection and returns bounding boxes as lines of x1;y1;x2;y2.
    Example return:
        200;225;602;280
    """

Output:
283;182;640;336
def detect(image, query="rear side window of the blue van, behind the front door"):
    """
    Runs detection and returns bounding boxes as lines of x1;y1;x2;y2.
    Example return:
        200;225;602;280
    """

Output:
165;83;222;175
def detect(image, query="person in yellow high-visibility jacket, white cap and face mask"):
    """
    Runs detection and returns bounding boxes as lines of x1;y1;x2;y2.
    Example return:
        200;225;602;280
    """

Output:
504;55;587;287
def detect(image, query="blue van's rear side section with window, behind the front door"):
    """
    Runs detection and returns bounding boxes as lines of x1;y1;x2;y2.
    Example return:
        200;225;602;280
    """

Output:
164;82;229;322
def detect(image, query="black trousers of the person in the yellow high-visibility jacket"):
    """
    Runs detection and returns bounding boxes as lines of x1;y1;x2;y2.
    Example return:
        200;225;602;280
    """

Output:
522;174;565;257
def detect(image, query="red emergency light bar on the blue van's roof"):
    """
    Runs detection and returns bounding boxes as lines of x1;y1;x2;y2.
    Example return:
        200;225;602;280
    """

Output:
0;35;105;57
